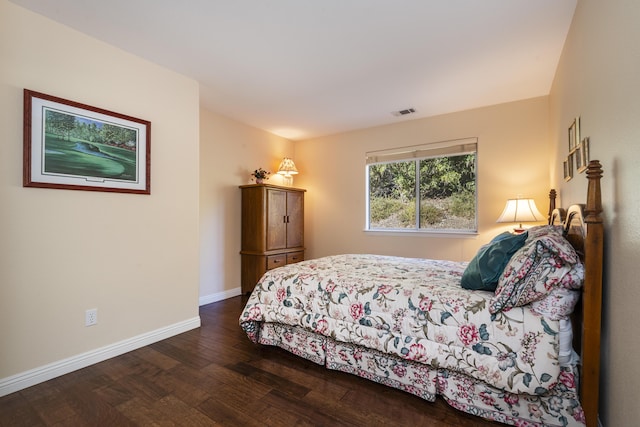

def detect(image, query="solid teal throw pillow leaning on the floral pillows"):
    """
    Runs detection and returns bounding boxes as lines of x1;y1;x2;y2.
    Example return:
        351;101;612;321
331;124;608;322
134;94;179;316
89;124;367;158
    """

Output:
462;231;528;291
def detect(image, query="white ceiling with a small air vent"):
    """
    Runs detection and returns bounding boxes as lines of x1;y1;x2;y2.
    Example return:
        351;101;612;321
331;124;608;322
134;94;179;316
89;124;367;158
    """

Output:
12;0;577;140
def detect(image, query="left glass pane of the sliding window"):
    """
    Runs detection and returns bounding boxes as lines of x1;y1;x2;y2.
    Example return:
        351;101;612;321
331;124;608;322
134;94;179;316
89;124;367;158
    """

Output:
369;161;416;229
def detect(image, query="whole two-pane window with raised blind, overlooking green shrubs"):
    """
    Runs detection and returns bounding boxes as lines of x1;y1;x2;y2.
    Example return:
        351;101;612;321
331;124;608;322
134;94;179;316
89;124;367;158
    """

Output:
366;138;477;232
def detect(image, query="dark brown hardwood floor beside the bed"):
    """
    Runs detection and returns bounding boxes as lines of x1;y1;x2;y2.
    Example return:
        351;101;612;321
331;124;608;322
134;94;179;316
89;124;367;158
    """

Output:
0;297;497;427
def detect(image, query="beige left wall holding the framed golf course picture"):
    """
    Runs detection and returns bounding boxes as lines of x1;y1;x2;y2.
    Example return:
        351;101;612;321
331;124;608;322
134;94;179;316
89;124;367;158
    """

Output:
0;0;199;385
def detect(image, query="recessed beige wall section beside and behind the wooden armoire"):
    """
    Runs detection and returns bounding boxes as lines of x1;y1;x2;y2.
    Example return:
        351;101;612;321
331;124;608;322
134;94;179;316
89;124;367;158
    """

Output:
200;110;294;304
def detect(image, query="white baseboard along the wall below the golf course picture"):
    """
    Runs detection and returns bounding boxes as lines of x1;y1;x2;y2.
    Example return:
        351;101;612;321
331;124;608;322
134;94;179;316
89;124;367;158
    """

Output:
0;316;200;397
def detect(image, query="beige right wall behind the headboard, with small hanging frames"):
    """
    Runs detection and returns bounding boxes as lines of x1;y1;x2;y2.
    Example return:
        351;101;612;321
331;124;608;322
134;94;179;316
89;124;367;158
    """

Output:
550;0;640;427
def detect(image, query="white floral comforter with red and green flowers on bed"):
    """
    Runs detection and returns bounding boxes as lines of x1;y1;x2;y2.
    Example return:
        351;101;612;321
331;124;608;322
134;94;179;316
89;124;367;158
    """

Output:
240;254;560;394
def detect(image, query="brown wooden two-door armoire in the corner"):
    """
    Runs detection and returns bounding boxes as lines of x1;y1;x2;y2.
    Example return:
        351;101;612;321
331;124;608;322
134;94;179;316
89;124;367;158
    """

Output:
240;184;306;294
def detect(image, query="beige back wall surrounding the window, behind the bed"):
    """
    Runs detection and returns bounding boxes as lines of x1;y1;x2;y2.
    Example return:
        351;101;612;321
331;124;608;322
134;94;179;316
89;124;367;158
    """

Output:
296;97;550;260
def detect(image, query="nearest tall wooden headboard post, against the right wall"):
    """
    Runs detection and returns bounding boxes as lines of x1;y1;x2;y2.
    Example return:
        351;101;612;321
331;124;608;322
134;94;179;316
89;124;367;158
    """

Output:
580;160;604;426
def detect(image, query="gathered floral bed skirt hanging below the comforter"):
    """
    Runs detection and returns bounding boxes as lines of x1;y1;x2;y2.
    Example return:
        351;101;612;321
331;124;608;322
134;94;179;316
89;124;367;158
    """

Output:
253;323;585;426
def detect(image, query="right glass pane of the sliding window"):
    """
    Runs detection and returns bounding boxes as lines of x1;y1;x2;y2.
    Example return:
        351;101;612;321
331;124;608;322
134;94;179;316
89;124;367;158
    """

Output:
420;154;477;230
